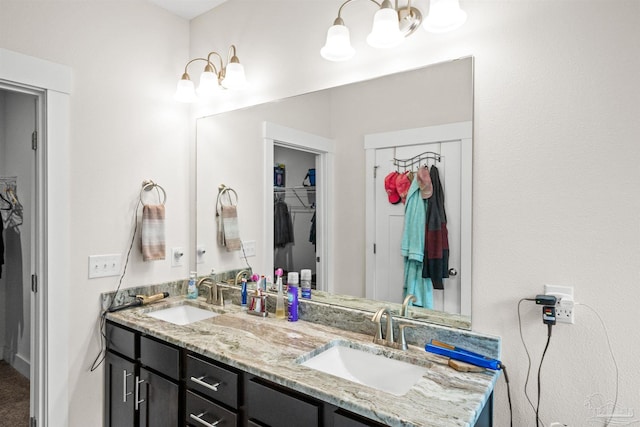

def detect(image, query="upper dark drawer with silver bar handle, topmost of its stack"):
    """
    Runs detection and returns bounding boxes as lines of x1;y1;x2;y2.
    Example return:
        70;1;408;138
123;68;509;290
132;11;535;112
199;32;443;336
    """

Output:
186;354;238;409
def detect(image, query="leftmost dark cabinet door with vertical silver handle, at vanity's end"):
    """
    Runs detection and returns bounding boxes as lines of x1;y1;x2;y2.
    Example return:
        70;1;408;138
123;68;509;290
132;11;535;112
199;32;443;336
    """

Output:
104;351;135;427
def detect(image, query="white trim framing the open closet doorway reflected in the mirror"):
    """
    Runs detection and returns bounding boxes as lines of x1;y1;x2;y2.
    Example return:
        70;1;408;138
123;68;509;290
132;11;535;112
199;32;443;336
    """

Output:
263;122;335;292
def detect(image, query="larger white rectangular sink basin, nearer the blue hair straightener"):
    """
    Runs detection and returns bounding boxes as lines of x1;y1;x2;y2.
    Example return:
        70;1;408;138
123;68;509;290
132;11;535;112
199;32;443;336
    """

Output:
301;342;427;396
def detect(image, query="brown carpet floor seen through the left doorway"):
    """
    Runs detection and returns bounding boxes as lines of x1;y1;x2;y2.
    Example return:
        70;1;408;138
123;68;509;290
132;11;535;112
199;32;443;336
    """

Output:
0;360;29;427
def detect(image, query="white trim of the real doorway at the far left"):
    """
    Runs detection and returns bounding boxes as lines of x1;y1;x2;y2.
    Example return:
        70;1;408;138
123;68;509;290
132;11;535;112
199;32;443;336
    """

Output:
0;48;72;427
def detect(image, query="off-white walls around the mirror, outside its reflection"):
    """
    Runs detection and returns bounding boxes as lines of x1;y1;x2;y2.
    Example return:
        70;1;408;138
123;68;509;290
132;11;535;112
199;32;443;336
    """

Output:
0;0;640;426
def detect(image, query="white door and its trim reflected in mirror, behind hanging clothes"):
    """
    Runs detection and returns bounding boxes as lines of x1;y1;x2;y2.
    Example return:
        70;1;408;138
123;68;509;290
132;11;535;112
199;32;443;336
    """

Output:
365;123;471;315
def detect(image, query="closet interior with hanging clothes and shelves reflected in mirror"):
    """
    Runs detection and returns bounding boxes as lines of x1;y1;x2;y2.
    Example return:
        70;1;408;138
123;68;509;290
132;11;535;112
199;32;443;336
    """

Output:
273;146;317;288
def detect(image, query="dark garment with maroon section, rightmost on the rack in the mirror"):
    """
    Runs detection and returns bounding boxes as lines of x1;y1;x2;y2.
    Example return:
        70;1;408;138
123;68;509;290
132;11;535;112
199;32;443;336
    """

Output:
422;166;449;289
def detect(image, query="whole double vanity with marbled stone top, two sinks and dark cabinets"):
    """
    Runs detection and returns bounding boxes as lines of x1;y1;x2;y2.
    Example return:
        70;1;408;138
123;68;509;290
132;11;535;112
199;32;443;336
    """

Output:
105;282;500;427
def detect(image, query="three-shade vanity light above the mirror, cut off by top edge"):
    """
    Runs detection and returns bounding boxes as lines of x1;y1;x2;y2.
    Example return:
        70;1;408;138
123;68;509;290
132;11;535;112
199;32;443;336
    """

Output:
320;0;467;61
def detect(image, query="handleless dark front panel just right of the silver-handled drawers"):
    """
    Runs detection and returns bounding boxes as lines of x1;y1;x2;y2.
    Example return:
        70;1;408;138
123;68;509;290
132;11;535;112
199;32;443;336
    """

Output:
247;380;321;427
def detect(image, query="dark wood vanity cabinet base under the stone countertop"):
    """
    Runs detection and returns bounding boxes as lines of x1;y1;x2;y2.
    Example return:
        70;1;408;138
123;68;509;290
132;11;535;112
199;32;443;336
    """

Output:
105;322;493;427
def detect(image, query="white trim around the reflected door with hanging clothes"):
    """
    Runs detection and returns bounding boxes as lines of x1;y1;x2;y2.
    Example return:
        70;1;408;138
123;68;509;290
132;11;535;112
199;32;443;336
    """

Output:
364;121;473;316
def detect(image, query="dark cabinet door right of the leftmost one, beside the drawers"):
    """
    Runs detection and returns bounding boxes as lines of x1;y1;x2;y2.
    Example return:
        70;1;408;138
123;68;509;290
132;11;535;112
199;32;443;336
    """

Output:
138;368;180;427
